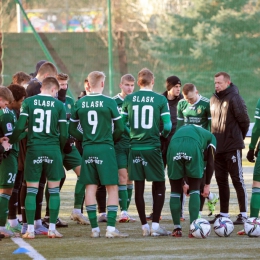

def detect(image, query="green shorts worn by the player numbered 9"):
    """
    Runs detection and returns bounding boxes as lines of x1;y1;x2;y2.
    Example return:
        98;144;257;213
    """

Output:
79;144;118;185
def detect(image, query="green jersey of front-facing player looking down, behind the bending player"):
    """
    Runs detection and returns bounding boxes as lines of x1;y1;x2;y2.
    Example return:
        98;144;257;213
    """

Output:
177;95;211;131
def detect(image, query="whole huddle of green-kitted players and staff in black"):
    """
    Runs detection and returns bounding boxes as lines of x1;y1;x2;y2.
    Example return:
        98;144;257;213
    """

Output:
0;61;260;239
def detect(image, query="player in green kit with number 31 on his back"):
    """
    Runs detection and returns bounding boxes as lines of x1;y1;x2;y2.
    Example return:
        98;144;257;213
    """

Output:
10;77;67;238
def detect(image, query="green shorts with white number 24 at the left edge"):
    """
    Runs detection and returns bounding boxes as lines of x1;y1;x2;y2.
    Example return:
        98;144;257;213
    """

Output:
0;150;18;189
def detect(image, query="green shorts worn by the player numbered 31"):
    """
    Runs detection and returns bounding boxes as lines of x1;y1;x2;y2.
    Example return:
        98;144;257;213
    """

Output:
24;145;64;182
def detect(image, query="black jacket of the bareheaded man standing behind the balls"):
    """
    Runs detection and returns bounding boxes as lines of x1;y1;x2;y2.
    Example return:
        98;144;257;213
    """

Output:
210;83;250;153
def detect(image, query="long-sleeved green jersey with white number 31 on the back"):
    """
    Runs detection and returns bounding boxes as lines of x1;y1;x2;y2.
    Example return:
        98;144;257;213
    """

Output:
9;94;67;147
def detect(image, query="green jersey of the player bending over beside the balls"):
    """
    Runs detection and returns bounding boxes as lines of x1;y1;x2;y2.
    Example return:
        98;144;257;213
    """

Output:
171;125;216;151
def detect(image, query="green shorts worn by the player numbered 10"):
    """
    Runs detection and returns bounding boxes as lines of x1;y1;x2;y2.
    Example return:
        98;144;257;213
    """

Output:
128;148;165;181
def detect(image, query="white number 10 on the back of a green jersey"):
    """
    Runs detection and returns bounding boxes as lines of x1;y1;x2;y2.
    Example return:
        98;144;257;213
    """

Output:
133;105;153;129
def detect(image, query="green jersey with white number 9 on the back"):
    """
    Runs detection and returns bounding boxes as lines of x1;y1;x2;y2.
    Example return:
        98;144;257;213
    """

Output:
70;93;121;146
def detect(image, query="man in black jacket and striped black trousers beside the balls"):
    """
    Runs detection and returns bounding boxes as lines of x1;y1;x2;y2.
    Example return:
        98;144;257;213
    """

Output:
210;72;250;225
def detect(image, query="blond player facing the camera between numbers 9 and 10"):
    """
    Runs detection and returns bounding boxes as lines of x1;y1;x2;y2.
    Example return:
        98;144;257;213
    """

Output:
114;74;135;223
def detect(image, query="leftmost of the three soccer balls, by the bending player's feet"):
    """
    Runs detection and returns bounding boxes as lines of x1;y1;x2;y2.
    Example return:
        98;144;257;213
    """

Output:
190;218;211;238
